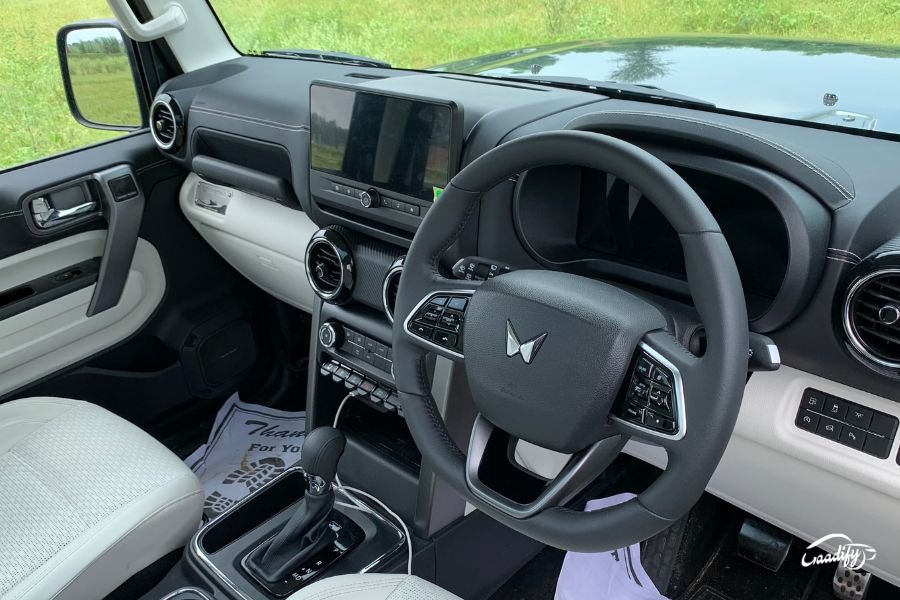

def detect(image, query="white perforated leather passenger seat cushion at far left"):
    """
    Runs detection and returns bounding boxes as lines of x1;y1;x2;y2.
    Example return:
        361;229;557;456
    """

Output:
0;398;203;600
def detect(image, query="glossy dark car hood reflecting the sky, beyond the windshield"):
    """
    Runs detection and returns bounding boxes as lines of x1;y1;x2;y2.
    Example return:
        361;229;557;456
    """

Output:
434;36;900;133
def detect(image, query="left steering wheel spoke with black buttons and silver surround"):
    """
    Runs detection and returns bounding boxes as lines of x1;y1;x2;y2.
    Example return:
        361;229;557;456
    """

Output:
403;277;479;361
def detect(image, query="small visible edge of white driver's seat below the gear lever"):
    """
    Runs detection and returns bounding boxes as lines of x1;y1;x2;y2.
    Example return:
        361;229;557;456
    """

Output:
288;574;459;600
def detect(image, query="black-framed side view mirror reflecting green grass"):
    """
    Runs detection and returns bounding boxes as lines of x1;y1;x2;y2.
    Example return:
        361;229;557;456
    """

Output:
56;20;146;131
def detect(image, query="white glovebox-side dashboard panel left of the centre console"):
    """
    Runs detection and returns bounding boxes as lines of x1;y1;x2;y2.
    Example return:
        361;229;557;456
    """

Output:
179;173;318;312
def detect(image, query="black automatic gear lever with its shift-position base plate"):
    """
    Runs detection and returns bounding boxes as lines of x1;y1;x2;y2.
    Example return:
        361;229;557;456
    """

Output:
242;427;365;597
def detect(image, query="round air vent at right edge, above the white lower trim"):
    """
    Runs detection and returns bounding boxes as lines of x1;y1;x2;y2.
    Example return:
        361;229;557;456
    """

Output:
843;269;900;368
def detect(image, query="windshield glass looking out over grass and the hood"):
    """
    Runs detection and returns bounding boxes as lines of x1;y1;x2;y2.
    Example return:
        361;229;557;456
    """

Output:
211;0;900;133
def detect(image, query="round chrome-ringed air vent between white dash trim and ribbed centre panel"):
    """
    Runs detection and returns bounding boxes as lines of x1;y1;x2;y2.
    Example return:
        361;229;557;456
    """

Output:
306;229;354;304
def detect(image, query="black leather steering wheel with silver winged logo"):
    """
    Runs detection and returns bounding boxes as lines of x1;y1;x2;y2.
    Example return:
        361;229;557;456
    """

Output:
393;131;748;552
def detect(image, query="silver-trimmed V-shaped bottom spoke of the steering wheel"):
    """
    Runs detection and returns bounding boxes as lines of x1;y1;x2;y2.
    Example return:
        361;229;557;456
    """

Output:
466;415;626;519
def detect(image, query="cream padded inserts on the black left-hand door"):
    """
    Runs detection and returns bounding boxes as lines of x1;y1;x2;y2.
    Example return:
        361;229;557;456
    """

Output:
0;231;166;396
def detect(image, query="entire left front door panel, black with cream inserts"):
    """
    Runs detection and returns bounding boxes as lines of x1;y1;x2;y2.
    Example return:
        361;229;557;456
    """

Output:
0;132;273;426
